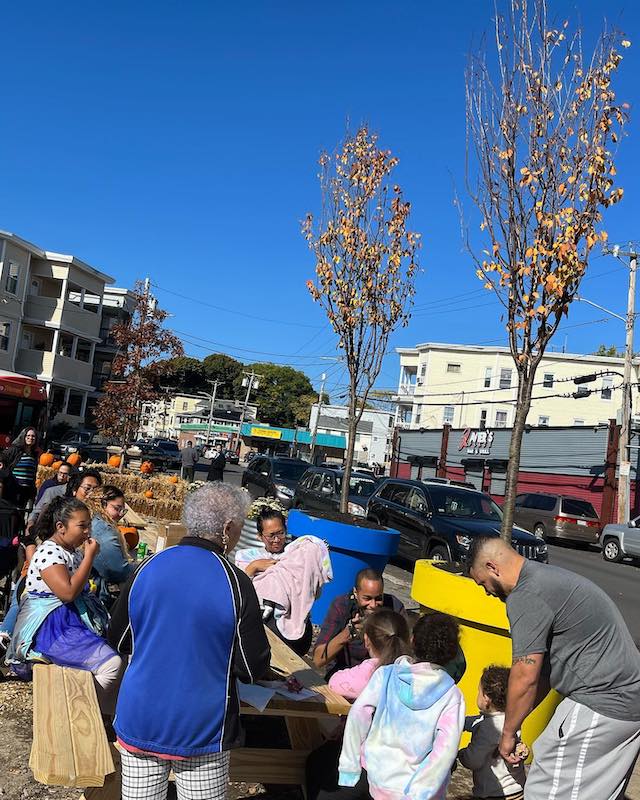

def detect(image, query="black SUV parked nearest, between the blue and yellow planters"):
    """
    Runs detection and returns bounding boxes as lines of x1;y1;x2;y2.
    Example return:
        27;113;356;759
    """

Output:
367;478;549;563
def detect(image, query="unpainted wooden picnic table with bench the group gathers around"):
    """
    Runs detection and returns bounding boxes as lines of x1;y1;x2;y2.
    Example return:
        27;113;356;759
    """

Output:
29;628;351;800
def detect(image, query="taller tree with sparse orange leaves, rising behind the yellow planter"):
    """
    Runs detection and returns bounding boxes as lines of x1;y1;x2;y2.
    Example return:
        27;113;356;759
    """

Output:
465;0;630;541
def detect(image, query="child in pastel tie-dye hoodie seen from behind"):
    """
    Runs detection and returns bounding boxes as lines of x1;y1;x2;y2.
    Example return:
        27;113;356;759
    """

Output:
340;613;465;800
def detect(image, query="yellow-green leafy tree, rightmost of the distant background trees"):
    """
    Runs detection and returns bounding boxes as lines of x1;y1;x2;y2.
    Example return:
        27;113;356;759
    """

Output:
235;364;317;428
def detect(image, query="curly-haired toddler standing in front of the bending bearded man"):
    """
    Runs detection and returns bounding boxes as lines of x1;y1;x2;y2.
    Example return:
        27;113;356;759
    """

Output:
458;666;527;800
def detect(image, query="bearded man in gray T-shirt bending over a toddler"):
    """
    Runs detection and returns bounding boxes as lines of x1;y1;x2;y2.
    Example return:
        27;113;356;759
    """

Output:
467;536;640;800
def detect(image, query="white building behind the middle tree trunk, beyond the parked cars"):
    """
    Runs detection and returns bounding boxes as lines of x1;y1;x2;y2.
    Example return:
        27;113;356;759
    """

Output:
309;403;394;465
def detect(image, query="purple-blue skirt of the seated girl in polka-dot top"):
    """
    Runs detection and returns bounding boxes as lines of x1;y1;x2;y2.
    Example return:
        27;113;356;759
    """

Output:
33;603;117;672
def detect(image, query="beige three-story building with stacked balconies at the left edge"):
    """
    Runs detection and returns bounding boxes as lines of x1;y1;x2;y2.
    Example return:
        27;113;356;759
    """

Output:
0;231;113;425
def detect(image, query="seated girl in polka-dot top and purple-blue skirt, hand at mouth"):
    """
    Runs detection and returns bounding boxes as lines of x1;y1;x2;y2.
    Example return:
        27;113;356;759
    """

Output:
7;497;121;715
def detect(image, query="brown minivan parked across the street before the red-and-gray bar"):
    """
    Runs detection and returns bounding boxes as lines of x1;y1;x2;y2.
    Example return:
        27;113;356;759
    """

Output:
513;492;602;543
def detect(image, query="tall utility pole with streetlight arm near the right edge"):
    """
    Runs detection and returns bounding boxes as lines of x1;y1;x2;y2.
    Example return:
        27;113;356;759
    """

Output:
604;245;638;524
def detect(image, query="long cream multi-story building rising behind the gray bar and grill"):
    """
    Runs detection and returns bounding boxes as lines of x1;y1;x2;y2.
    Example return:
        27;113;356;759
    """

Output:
394;342;638;428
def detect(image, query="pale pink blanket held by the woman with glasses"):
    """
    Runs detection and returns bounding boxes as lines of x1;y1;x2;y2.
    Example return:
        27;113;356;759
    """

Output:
253;536;333;641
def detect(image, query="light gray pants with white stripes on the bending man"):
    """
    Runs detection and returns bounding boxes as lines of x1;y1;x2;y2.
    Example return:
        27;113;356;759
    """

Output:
524;699;640;800
